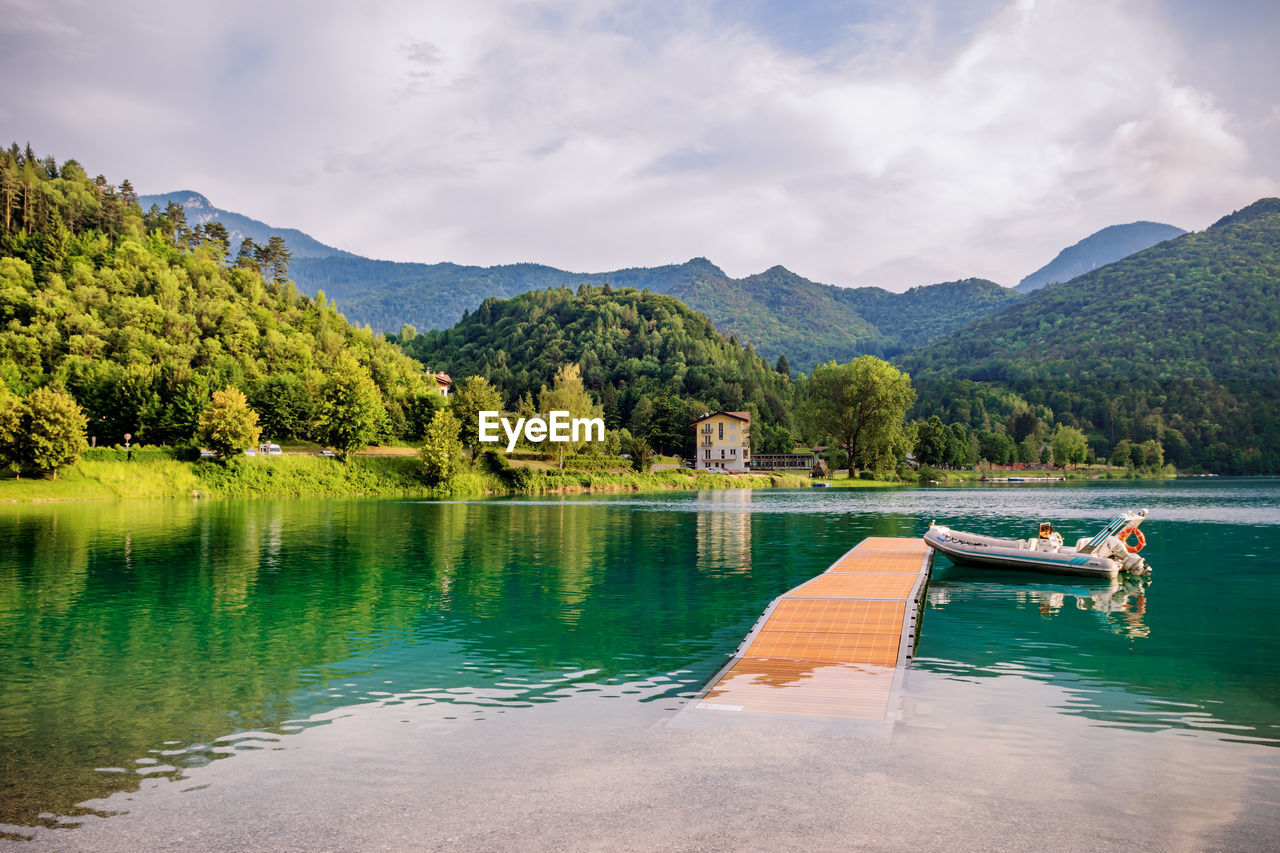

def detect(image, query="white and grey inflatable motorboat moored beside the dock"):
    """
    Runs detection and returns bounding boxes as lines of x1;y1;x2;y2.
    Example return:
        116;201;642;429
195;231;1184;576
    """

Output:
924;510;1148;578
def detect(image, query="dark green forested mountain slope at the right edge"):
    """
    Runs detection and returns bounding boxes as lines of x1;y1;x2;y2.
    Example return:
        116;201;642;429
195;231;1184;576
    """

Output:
901;199;1280;473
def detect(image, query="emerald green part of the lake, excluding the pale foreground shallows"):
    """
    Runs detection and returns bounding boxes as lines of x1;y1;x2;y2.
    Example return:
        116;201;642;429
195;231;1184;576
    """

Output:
0;480;1280;843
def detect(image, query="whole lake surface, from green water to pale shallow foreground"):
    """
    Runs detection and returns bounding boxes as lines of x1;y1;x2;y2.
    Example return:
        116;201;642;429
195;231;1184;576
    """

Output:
0;479;1280;849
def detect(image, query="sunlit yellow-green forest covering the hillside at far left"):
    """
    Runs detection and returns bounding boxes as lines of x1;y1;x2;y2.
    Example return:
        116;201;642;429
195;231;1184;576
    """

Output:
0;145;434;446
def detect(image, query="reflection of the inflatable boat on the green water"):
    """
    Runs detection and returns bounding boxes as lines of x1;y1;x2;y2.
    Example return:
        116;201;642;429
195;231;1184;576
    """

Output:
927;563;1151;639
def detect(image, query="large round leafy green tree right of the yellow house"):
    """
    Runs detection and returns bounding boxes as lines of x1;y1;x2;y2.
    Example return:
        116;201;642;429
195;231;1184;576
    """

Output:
805;356;915;473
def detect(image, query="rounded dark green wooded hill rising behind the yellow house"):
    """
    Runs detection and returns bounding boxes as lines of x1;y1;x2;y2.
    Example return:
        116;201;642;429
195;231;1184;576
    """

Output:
392;284;796;457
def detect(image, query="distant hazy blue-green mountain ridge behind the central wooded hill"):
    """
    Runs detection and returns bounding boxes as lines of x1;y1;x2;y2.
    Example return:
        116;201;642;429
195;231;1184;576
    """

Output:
291;249;1019;370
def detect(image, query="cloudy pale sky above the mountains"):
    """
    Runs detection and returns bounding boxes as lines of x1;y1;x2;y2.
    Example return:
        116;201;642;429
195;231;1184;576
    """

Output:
0;0;1280;291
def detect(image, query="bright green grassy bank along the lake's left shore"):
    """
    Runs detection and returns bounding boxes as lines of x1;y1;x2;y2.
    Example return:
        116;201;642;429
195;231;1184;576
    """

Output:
0;448;808;501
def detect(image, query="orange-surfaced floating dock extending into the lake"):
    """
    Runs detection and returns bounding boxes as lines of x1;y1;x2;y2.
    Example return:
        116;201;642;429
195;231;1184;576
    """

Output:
690;537;932;721
